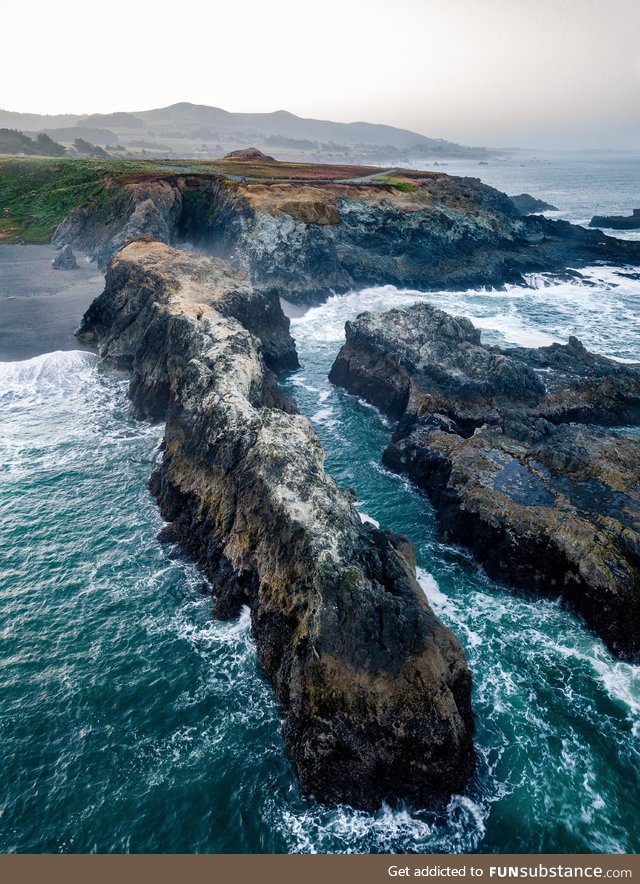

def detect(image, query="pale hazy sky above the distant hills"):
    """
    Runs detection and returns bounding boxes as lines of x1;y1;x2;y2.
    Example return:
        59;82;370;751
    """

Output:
5;0;640;147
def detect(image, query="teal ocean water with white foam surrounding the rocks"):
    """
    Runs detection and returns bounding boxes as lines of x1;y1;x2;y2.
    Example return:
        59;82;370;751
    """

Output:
0;154;640;853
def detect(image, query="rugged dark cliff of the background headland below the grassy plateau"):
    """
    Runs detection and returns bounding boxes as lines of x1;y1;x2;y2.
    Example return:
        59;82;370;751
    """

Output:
53;160;640;303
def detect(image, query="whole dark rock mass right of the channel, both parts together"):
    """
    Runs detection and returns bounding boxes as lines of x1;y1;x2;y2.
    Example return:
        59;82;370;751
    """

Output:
330;304;640;661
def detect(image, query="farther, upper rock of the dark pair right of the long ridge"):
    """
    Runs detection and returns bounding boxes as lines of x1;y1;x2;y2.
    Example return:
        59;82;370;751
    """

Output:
329;304;640;435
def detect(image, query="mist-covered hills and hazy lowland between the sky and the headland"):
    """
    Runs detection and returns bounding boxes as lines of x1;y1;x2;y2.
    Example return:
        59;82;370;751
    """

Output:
0;102;487;162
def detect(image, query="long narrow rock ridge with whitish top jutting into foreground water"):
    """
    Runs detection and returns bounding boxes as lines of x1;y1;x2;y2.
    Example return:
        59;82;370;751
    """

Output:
79;242;474;808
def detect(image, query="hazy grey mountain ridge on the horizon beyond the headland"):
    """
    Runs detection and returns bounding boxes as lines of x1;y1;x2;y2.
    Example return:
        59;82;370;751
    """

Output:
0;102;484;161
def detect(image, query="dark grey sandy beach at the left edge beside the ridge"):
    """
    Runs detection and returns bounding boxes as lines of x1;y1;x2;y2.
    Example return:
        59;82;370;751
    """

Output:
0;245;104;362
